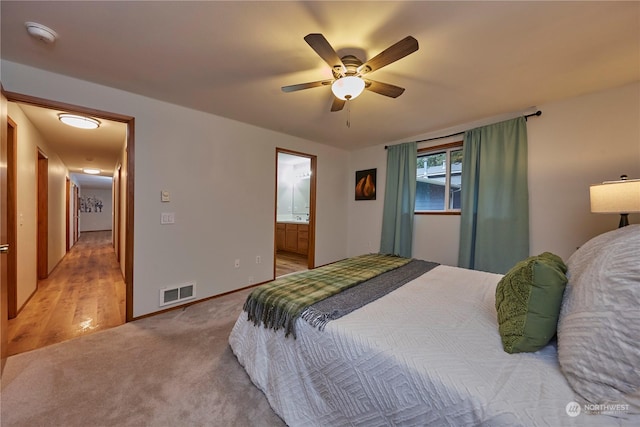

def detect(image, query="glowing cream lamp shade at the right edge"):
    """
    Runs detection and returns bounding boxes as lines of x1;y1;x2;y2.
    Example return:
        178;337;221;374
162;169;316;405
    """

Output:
589;179;640;214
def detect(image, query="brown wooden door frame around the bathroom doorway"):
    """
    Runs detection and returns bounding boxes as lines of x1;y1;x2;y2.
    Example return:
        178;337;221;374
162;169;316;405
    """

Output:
273;147;318;277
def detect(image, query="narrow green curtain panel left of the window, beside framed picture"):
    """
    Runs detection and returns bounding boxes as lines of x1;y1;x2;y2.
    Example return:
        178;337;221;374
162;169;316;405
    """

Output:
380;142;418;257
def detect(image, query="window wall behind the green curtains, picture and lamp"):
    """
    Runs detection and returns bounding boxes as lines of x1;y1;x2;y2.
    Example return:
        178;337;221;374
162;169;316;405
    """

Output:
348;83;640;265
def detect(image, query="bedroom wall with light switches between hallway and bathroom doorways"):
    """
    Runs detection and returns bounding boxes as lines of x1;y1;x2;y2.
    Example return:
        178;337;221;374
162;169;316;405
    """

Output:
2;61;348;316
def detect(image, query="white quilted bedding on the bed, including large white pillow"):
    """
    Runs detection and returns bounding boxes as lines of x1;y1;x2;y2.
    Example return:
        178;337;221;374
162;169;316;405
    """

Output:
229;226;640;426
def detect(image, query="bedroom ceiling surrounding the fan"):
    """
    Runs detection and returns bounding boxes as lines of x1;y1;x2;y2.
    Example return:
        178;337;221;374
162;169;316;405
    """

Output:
0;0;640;159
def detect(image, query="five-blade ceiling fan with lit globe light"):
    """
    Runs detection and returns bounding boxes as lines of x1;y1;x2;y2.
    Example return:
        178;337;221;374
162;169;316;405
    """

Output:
282;33;418;111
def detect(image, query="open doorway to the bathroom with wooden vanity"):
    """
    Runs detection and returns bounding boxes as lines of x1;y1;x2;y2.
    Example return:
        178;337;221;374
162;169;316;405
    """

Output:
274;148;316;277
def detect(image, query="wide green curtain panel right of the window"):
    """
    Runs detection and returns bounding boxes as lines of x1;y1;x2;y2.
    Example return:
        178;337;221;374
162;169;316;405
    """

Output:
458;117;529;274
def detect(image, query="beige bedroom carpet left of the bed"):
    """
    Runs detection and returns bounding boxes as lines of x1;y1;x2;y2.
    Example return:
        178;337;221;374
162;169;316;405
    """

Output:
0;290;284;427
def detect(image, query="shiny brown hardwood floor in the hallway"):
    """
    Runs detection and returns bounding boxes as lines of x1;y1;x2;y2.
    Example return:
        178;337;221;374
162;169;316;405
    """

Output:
8;231;125;355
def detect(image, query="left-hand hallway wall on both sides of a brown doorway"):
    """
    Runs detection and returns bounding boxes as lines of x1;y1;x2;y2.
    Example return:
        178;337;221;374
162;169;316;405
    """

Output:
8;102;67;309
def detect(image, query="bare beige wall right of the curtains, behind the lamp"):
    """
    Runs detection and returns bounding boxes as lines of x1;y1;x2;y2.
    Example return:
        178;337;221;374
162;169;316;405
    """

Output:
527;83;640;259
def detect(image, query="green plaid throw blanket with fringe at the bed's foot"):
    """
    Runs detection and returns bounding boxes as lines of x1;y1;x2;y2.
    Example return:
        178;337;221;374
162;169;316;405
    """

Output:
244;254;411;338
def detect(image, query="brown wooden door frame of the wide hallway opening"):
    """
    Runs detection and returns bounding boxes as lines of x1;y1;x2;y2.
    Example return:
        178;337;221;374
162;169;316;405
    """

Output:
3;91;135;322
